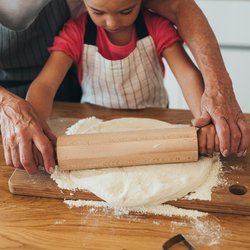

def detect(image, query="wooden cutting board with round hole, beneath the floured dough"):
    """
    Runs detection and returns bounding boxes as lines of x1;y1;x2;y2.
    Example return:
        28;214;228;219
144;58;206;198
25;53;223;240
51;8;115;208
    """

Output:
6;118;250;215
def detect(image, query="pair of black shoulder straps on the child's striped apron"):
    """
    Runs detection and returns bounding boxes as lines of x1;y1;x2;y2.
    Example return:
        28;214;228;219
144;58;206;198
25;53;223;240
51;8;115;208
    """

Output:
84;11;149;45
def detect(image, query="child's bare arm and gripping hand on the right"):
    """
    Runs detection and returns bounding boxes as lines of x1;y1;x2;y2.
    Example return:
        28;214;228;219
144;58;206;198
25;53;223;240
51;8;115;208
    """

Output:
163;43;219;156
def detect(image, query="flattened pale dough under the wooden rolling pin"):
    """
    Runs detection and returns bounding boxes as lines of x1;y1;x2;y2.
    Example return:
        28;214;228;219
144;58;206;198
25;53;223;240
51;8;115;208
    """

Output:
52;117;214;207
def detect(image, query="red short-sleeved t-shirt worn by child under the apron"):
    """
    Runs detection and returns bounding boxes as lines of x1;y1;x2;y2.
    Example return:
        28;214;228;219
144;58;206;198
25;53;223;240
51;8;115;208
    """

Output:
49;10;181;82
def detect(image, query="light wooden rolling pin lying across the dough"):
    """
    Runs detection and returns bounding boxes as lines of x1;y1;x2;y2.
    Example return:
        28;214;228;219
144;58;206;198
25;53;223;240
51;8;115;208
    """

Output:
57;127;198;170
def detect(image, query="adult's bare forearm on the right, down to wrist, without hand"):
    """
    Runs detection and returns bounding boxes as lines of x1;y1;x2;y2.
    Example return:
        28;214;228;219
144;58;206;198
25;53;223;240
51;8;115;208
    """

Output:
144;0;231;92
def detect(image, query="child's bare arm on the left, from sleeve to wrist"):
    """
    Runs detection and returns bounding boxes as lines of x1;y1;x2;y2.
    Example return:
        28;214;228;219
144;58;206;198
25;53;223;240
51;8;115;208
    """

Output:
26;51;73;121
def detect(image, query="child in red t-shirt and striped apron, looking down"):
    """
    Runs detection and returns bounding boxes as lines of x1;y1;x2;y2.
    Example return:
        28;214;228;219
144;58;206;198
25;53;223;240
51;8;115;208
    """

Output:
27;0;218;155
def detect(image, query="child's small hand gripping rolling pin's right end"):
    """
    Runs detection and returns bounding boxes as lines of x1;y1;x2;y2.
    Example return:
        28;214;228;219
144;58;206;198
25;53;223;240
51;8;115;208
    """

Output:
198;124;219;157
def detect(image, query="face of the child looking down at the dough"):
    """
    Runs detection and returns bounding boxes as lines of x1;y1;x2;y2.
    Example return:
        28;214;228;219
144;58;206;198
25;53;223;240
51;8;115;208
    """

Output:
84;0;142;33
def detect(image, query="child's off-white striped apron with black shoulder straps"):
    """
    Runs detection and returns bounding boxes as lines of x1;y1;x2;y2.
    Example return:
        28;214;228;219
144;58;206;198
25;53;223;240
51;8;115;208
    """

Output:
81;13;168;109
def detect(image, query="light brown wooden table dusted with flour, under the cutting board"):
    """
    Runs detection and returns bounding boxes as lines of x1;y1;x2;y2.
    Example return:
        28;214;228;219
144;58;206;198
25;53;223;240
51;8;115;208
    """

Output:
0;103;250;250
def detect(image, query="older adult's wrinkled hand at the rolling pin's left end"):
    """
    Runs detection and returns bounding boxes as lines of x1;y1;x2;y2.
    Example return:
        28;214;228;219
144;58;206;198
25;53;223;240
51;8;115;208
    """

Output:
0;89;56;174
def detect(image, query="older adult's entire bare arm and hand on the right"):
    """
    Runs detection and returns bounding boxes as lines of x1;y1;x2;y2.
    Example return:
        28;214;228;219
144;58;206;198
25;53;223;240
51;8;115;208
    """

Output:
144;0;250;156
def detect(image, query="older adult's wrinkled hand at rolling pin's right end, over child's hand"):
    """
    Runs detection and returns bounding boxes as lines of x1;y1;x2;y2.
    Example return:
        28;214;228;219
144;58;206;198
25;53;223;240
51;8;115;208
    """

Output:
192;81;250;157
